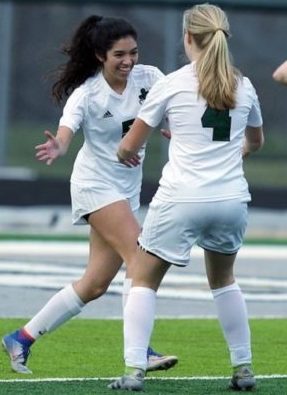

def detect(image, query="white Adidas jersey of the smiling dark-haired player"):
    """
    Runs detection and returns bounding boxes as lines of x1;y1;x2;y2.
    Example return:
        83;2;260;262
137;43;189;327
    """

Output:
59;65;163;198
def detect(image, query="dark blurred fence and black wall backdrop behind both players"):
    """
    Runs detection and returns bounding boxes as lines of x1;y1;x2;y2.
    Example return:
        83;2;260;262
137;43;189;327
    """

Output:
0;0;287;210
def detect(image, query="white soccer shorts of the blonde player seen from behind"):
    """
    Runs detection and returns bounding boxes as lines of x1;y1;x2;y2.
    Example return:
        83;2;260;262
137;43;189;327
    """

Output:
139;198;248;266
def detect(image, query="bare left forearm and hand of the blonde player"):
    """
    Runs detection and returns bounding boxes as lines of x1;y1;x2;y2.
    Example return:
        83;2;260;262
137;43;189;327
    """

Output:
117;118;152;166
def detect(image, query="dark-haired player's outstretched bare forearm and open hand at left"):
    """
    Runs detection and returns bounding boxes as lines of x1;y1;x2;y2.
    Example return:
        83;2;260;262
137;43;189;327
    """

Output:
35;126;73;165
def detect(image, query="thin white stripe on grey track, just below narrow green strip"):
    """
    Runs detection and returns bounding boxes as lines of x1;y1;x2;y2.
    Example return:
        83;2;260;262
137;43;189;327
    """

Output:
0;241;287;260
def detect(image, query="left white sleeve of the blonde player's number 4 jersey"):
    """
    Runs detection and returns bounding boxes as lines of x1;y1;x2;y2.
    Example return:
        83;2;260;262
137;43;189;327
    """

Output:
137;78;168;128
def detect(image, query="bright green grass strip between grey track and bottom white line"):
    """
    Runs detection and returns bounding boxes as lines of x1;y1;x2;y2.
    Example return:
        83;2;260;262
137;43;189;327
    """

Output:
0;319;287;380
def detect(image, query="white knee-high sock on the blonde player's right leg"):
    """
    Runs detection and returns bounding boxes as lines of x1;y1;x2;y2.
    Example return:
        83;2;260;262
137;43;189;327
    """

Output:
212;283;252;366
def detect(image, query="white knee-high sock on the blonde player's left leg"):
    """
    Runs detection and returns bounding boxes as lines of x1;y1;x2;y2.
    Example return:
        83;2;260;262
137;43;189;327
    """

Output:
124;287;156;370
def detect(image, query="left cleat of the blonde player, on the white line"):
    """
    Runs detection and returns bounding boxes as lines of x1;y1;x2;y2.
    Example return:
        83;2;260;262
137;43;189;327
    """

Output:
108;368;145;391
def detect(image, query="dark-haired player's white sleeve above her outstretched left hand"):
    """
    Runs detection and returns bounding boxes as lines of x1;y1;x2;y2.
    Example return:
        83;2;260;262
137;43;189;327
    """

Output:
59;88;85;133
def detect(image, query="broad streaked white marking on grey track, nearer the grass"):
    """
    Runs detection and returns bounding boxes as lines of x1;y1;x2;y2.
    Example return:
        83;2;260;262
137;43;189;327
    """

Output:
0;261;287;302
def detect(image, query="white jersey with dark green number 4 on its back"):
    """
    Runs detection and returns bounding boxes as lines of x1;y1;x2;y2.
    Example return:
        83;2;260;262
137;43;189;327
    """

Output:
138;62;262;202
